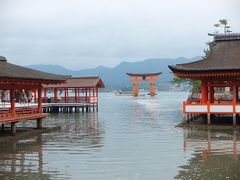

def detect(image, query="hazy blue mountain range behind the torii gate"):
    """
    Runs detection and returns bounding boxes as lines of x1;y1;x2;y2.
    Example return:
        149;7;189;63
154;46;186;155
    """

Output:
28;56;201;87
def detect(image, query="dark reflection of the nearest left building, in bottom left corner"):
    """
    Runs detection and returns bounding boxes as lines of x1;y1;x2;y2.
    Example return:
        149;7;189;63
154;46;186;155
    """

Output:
0;135;60;179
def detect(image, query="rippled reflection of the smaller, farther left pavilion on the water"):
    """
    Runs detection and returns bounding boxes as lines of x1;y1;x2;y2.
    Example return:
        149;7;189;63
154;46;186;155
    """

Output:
47;112;103;151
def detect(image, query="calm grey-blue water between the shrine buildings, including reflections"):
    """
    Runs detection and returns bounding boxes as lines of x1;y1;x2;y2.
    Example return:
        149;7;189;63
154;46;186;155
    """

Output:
0;92;240;180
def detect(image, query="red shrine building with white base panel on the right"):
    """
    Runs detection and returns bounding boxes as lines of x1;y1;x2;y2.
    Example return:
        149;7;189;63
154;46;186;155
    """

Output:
169;34;240;125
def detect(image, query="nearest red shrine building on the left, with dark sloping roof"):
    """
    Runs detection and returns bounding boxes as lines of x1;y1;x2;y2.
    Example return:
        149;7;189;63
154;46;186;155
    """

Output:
0;56;69;135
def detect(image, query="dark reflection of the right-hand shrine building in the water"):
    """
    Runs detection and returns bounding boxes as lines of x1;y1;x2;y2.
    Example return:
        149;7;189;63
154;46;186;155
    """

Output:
175;129;240;180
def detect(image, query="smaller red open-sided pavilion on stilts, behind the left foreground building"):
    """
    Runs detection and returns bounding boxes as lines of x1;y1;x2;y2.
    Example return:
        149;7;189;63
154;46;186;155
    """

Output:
42;76;105;113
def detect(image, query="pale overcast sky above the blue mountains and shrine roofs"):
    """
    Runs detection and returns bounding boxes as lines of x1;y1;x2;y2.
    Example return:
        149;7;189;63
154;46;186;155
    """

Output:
0;0;240;70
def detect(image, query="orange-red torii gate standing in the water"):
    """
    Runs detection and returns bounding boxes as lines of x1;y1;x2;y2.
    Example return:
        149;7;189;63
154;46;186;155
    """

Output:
127;72;162;97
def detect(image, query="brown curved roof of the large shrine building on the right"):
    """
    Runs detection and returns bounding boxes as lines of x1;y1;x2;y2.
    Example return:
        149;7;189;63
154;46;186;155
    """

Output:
169;34;240;74
